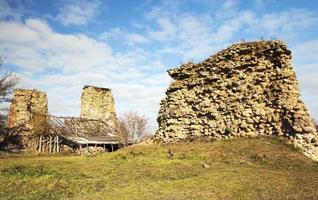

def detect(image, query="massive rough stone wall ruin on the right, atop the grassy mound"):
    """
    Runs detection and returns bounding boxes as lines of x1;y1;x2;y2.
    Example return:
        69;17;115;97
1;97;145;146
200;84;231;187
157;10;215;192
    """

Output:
155;41;318;160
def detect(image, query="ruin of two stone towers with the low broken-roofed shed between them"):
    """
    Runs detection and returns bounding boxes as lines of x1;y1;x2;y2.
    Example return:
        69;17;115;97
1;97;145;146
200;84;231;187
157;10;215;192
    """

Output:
9;86;119;153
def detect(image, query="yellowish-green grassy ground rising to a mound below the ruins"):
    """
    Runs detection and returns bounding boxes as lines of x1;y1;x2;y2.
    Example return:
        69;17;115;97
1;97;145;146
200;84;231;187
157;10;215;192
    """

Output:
0;137;318;200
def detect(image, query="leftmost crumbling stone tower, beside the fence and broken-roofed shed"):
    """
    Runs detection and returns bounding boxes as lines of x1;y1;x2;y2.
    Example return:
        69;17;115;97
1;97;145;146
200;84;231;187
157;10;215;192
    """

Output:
9;89;48;150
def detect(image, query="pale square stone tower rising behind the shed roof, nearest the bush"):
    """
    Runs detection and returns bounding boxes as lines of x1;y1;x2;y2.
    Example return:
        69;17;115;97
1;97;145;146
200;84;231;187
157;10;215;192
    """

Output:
81;85;116;127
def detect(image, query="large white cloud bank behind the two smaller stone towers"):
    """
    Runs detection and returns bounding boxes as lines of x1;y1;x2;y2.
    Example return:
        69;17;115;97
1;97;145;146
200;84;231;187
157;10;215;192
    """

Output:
0;19;169;130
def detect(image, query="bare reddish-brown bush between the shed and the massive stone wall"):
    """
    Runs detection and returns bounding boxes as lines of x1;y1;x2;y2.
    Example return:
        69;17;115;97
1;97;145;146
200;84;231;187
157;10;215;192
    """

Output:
116;111;149;146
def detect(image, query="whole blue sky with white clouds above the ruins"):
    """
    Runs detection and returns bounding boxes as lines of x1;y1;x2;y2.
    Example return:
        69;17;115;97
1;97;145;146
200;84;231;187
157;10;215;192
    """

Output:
0;0;318;128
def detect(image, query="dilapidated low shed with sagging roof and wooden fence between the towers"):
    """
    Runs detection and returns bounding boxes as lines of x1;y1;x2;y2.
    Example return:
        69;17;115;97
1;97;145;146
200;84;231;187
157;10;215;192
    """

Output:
38;116;119;153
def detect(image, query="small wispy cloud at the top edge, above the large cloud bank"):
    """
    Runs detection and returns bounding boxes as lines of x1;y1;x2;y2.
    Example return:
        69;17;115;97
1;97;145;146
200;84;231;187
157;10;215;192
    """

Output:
57;0;101;26
